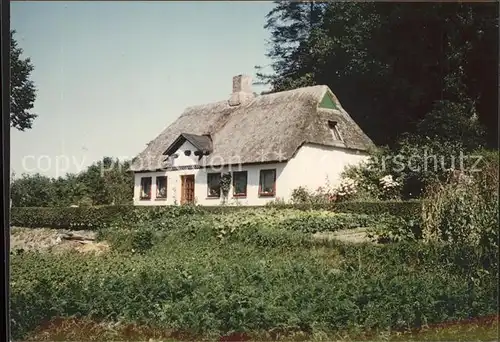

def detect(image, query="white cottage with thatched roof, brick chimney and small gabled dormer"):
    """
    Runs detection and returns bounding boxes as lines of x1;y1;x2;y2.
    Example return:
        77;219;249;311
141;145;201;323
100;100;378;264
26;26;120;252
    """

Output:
131;75;374;205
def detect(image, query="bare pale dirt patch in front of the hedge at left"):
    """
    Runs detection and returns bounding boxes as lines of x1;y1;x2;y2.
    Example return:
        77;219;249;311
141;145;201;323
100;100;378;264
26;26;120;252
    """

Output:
10;227;109;254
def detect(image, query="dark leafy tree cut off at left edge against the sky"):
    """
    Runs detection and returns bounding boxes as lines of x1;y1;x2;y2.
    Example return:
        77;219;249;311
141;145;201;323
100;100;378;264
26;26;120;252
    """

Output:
10;30;37;131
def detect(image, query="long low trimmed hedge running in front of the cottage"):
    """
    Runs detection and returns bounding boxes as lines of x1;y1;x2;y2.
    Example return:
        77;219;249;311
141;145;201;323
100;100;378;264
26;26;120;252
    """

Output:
11;201;420;230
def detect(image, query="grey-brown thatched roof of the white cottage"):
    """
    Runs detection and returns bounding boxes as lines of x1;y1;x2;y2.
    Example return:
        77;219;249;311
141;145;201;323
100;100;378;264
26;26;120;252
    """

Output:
131;85;374;171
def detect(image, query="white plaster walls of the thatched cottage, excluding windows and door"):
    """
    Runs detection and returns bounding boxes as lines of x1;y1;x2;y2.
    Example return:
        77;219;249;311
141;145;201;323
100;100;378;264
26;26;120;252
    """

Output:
134;144;368;205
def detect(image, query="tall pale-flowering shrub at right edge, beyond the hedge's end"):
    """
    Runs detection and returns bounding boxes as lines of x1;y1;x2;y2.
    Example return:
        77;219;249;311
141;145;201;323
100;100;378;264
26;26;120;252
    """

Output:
422;154;499;256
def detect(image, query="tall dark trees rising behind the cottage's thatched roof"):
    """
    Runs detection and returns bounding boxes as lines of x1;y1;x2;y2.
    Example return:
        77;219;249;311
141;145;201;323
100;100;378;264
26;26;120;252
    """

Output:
258;2;498;145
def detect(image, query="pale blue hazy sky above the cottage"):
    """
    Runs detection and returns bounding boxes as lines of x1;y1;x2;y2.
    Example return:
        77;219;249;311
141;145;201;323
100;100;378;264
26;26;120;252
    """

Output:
11;1;274;177
